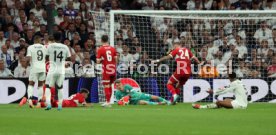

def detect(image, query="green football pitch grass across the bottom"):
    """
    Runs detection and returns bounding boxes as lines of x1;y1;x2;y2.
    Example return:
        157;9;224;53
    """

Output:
0;103;276;135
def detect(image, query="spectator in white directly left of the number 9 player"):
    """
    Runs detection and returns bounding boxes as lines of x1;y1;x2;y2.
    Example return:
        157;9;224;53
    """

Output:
14;57;30;78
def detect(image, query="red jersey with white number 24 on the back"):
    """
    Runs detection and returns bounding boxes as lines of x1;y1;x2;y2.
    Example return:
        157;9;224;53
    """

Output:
170;47;194;74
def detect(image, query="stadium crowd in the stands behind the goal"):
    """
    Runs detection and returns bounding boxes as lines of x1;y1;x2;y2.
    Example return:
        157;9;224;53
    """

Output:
0;0;276;78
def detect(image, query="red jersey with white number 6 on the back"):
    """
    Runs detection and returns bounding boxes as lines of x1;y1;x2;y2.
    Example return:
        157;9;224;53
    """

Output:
97;45;117;75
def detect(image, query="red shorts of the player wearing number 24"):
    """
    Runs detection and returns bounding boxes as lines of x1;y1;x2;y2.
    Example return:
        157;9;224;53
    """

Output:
169;72;191;86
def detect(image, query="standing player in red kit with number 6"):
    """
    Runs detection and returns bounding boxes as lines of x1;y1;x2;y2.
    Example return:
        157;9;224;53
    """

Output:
97;35;117;107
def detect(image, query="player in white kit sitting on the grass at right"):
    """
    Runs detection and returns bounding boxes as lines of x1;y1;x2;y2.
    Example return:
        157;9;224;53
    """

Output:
192;72;248;109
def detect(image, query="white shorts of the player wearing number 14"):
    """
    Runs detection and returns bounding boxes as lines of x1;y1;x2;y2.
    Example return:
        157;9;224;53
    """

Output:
46;74;65;87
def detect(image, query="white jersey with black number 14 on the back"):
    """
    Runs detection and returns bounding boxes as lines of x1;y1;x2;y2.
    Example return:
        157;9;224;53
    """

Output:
47;43;71;74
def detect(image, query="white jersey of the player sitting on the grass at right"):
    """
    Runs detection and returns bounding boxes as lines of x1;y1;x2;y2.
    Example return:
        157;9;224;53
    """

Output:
215;79;248;107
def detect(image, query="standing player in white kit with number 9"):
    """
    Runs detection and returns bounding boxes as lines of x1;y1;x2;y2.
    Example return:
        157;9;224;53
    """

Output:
27;36;46;108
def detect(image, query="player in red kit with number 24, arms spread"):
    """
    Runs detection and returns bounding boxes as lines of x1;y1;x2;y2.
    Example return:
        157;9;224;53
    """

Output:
154;43;200;104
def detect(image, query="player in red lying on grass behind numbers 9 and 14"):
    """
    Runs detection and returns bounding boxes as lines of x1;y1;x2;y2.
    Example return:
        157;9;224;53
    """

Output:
20;88;89;108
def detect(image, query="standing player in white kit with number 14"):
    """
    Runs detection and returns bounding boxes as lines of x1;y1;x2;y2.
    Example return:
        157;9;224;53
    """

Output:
45;33;71;110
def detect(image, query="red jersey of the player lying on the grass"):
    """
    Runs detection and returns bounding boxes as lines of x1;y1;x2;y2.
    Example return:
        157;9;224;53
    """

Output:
62;93;85;107
